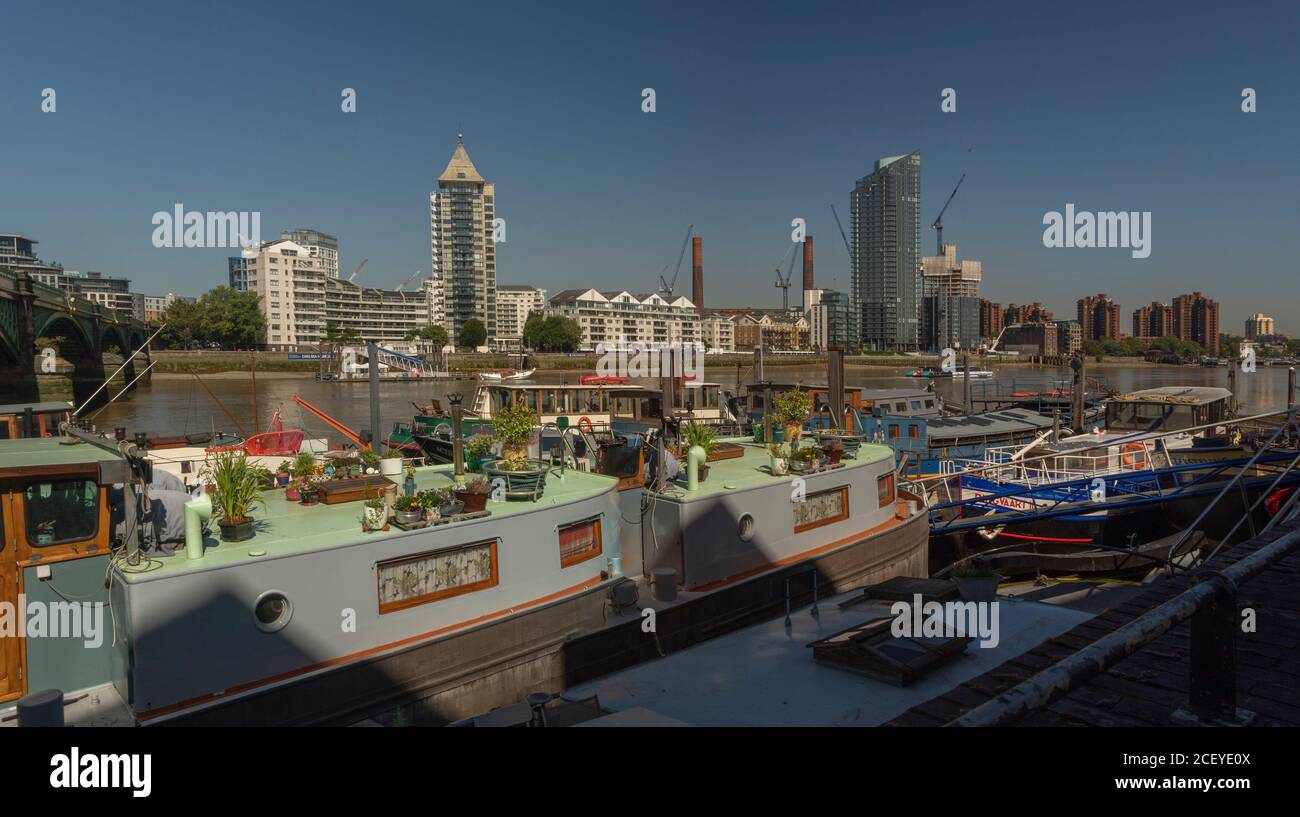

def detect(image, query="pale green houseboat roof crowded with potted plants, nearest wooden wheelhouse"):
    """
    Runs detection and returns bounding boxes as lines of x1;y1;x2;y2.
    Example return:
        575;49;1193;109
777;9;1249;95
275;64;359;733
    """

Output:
121;464;616;584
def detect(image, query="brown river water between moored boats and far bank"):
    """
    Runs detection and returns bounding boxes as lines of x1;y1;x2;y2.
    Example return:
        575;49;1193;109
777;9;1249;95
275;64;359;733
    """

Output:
94;364;1287;440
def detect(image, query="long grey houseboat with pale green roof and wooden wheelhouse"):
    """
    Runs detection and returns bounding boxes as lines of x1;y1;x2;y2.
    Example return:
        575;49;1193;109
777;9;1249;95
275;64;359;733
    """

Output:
0;428;928;725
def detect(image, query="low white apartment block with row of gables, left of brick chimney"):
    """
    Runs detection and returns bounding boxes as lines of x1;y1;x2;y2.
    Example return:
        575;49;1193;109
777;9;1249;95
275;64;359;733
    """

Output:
546;289;703;350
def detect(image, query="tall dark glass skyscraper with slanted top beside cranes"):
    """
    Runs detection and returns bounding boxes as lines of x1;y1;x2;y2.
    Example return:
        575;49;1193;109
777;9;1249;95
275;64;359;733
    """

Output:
849;151;923;351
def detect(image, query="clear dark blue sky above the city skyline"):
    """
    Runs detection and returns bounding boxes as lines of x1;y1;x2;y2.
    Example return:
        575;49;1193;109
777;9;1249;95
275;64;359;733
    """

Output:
0;1;1300;333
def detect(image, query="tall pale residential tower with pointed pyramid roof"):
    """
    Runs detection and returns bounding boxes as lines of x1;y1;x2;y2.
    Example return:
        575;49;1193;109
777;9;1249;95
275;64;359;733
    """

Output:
429;135;497;346
